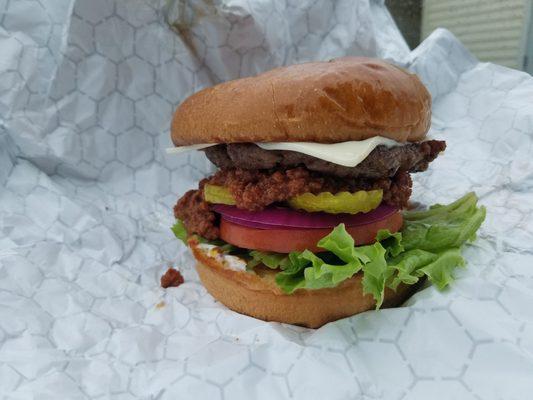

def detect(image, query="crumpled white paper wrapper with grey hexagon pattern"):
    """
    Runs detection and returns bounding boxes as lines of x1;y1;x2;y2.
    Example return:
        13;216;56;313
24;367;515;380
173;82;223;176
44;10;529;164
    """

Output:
0;0;533;399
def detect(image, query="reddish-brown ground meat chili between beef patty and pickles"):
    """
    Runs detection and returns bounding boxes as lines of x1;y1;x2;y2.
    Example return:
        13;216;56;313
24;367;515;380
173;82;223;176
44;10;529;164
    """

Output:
174;167;412;240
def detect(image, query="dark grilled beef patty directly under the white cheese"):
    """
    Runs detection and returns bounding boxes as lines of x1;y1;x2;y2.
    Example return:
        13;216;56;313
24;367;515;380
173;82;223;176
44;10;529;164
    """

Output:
204;140;446;179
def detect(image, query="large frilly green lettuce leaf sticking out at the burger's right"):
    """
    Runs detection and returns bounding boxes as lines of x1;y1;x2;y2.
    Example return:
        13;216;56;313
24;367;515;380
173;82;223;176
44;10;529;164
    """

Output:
276;193;486;308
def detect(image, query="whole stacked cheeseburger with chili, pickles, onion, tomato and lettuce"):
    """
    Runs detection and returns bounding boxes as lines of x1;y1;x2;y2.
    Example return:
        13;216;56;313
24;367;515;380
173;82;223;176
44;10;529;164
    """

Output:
169;58;485;328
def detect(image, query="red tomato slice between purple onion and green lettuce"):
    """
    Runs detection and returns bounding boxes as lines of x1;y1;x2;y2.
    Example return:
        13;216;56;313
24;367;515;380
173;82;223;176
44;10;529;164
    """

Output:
220;212;403;253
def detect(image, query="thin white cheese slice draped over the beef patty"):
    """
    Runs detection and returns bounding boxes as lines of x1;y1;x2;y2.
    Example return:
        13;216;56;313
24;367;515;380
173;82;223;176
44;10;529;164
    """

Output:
167;136;402;167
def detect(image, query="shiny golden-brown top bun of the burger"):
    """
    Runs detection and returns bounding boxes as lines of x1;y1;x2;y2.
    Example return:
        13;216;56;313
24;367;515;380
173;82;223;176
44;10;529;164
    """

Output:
171;57;431;146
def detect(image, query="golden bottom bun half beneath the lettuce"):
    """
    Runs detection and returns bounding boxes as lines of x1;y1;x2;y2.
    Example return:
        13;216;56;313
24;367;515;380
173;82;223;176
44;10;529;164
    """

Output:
189;240;416;328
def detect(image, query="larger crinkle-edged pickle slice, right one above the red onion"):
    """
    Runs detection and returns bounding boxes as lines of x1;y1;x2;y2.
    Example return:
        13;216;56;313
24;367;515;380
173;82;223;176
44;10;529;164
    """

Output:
288;190;383;214
